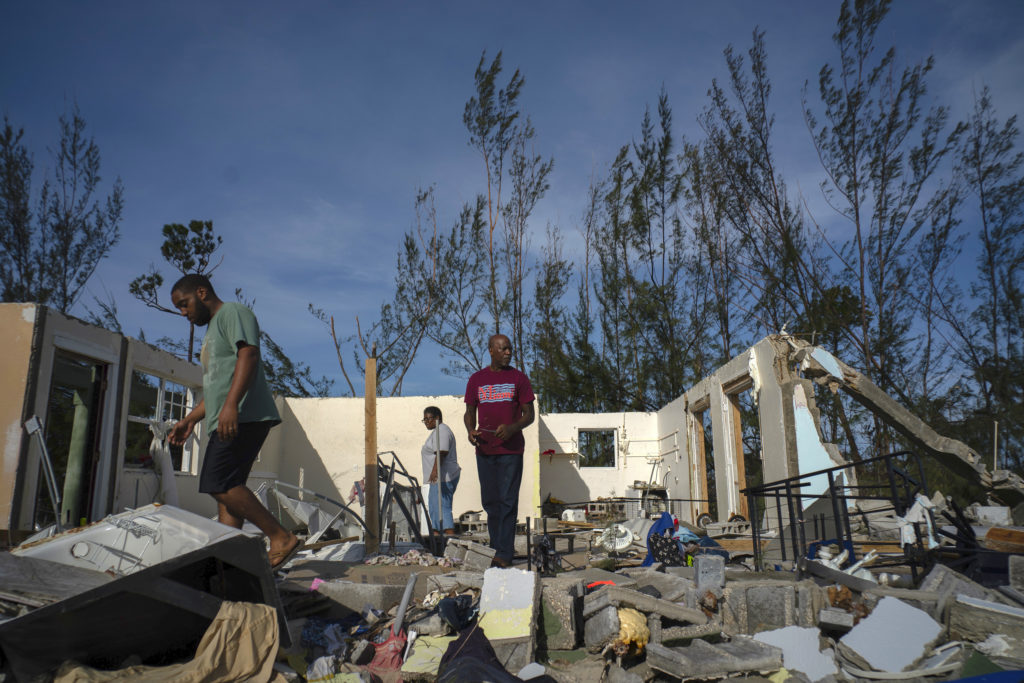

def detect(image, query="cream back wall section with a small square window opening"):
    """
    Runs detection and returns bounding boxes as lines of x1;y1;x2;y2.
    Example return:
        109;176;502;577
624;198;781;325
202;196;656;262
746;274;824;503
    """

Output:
539;413;664;503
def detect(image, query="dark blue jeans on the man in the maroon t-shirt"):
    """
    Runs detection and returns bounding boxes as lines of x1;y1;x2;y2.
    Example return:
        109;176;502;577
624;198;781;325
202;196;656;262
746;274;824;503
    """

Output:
476;453;522;562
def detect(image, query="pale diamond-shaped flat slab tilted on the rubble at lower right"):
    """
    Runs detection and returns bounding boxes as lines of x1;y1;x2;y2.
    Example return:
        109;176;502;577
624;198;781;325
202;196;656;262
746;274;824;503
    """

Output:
839;596;942;673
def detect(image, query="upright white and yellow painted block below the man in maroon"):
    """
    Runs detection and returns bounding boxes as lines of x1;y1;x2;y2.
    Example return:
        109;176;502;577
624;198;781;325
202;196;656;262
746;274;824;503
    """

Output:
479;567;541;671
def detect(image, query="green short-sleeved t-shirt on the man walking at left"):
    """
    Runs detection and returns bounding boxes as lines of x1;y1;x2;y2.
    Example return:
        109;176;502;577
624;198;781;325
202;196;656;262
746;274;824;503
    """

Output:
200;303;281;433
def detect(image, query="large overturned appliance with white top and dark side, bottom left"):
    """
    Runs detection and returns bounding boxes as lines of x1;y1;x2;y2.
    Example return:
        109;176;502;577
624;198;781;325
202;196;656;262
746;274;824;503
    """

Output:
0;505;288;680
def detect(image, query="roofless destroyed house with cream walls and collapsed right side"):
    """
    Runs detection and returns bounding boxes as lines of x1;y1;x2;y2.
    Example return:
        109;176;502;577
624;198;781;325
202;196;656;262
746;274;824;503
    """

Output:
0;304;1020;543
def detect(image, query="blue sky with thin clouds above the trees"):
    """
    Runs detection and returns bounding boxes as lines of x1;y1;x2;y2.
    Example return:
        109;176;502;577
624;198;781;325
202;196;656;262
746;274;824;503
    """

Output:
0;0;1024;394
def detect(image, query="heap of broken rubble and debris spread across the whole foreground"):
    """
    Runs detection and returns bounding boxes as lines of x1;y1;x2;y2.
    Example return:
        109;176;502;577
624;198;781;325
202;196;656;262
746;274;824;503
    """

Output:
0;499;1024;683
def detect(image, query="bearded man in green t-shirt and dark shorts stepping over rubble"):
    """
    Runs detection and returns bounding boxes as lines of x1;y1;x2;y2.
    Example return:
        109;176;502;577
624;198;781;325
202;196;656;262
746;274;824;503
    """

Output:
170;274;301;568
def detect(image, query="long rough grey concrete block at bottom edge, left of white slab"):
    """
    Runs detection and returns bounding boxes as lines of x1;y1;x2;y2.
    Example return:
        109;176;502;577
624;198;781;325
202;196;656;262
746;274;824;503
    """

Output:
647;636;782;681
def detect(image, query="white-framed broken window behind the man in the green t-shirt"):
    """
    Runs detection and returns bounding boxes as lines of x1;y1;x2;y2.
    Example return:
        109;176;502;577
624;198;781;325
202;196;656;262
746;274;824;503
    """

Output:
125;370;198;472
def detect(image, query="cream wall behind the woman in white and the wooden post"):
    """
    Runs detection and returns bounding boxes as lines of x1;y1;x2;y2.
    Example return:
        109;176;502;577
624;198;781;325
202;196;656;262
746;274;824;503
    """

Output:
260;396;539;519
